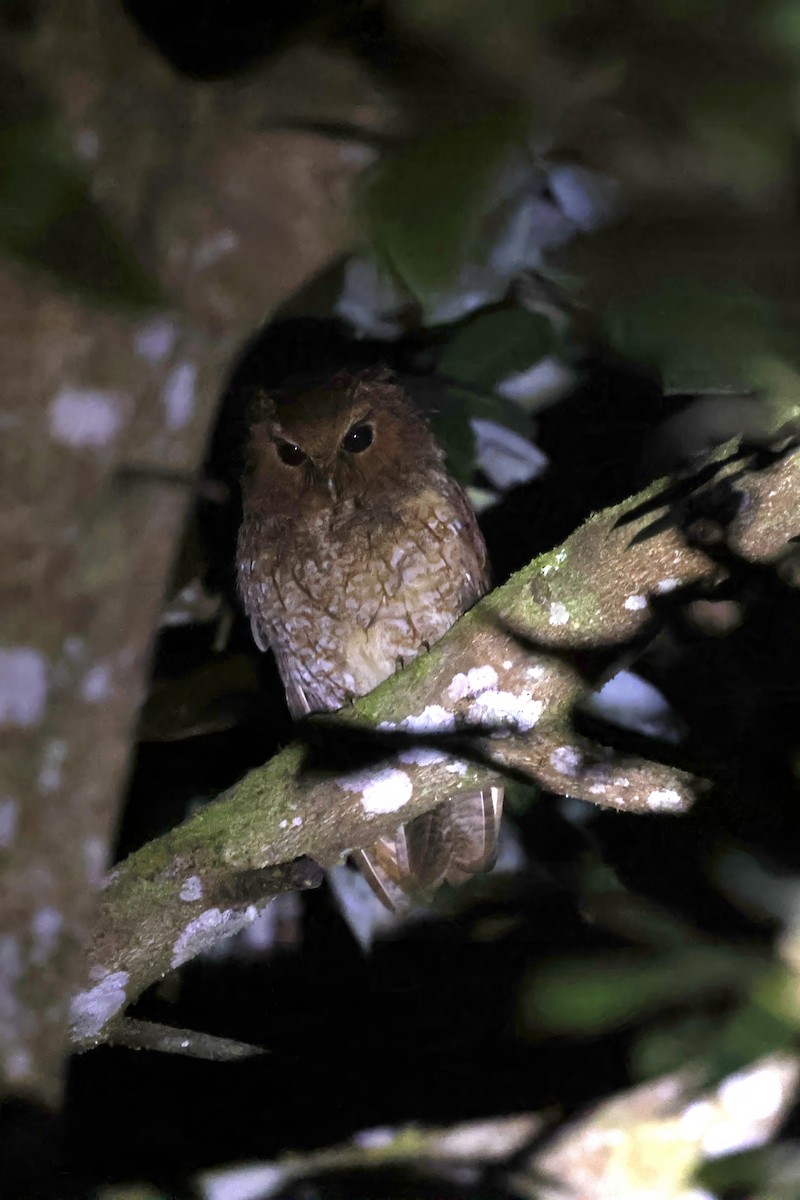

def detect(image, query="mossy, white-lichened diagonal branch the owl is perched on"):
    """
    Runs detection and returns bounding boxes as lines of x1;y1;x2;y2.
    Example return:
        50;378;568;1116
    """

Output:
74;436;800;1045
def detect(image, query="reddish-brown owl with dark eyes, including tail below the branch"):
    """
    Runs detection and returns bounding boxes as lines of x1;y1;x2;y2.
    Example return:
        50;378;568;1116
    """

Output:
237;371;503;908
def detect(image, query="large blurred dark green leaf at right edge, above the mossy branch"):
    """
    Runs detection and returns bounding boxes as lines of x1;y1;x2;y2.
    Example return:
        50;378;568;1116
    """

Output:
558;214;800;391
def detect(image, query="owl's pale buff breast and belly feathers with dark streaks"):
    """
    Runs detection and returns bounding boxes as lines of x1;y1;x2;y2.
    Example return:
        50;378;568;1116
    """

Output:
240;476;487;716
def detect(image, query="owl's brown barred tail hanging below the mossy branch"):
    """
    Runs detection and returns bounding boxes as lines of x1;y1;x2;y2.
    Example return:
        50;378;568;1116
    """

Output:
353;787;504;912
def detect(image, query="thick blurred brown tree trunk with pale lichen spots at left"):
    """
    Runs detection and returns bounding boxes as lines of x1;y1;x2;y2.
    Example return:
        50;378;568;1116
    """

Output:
0;0;385;1103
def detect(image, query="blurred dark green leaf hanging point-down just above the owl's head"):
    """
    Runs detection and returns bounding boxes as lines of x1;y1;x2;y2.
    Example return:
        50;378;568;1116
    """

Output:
363;107;528;305
